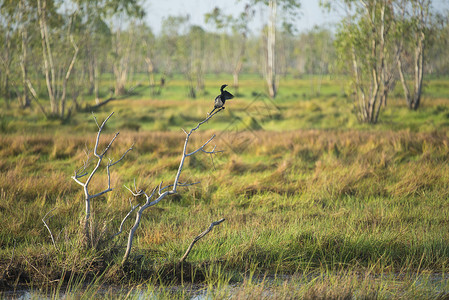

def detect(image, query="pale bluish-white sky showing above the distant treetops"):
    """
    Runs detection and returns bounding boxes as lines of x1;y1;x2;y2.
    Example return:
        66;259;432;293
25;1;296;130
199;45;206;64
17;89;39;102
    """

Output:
144;0;340;33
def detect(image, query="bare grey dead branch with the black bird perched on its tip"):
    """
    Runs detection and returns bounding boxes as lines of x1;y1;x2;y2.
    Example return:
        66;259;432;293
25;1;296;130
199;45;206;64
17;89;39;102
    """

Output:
122;109;223;265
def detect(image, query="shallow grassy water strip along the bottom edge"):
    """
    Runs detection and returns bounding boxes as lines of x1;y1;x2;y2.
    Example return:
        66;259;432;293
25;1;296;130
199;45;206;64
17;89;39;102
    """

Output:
0;272;449;300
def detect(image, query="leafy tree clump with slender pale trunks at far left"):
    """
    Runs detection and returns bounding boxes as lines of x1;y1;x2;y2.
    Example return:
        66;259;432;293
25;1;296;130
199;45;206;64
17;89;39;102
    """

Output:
26;0;143;118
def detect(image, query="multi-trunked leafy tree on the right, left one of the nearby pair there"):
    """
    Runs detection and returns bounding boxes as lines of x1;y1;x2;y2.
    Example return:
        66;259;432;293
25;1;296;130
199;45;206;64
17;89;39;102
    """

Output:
328;0;398;124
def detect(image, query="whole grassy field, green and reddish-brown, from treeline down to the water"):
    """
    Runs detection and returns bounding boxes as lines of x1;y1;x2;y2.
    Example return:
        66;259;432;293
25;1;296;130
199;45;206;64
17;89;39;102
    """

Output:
0;75;449;299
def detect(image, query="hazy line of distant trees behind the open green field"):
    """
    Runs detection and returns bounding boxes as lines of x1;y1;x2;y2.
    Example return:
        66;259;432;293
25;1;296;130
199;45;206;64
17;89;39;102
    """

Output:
0;0;449;116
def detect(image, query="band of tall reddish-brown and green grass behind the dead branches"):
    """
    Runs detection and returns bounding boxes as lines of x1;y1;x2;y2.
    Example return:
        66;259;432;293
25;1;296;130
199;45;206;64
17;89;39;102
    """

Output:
0;130;449;286
